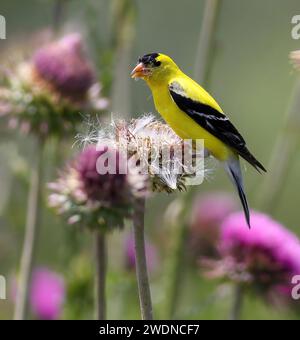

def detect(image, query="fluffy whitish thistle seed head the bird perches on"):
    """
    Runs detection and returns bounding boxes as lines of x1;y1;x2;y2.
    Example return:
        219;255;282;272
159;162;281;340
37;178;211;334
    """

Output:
78;114;209;193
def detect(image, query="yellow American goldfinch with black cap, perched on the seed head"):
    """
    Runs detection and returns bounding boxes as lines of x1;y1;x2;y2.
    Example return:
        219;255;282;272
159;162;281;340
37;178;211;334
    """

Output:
131;53;266;227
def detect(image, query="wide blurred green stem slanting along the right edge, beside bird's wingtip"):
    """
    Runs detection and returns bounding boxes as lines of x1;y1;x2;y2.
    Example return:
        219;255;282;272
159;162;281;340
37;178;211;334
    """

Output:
258;80;300;213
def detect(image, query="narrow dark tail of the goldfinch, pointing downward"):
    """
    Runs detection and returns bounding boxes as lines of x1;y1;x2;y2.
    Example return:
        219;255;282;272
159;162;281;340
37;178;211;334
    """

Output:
225;158;251;228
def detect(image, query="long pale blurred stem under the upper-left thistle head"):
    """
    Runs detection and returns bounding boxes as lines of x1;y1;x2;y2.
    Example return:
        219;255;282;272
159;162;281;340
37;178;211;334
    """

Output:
14;141;43;320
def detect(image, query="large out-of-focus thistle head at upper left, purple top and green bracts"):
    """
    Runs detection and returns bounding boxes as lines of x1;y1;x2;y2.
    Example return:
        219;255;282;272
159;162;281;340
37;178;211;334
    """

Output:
0;33;108;138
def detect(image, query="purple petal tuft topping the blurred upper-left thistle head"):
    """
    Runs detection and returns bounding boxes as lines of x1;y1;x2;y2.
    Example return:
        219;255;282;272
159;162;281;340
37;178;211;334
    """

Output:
33;33;95;101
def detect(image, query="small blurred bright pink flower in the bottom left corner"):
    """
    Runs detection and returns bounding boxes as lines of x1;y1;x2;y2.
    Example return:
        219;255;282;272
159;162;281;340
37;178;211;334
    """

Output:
30;268;65;320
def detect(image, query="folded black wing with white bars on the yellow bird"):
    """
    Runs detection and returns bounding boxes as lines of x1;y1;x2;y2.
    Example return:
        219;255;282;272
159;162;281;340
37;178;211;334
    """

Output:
169;83;266;171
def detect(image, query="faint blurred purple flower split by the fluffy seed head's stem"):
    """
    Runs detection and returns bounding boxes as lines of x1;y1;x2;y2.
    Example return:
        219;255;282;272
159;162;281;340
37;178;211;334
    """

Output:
125;234;158;272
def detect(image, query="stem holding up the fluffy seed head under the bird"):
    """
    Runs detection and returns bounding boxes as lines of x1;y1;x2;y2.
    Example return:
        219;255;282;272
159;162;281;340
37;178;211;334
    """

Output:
133;199;153;320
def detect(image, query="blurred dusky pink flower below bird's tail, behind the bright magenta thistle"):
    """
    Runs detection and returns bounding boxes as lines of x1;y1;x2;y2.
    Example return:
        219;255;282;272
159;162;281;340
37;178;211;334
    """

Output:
189;192;237;257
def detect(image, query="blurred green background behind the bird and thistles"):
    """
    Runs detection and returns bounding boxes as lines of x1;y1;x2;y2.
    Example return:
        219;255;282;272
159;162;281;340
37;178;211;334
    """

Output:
0;0;300;319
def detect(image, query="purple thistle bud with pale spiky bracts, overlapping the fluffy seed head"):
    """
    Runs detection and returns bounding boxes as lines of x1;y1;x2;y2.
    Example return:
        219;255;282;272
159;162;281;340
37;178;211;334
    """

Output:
49;145;147;228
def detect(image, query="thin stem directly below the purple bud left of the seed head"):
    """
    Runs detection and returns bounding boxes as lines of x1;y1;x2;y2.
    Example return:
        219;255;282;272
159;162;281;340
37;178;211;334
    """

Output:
95;230;107;320
